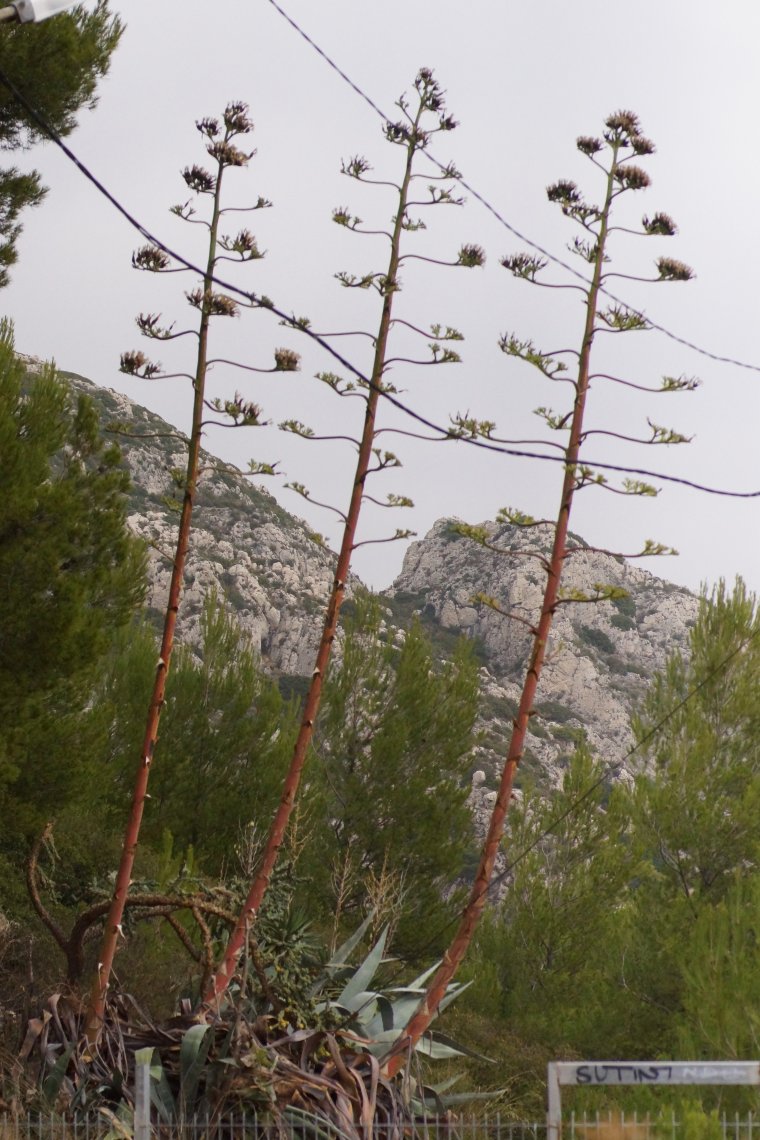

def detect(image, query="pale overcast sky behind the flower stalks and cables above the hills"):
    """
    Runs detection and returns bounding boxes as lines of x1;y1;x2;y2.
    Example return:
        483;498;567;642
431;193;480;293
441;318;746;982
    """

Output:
2;0;760;589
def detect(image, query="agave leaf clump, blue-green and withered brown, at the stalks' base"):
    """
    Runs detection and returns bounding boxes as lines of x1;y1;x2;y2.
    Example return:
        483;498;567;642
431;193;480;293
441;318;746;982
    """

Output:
22;915;496;1140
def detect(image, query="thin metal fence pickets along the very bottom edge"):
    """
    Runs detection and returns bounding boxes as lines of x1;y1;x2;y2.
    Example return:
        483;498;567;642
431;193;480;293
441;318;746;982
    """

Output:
0;1109;760;1140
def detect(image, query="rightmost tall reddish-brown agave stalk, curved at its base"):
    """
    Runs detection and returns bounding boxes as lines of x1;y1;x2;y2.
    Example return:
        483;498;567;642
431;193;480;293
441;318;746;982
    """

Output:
385;112;690;1076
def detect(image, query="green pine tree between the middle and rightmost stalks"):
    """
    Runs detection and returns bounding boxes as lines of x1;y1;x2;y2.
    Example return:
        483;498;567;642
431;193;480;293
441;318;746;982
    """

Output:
316;597;479;956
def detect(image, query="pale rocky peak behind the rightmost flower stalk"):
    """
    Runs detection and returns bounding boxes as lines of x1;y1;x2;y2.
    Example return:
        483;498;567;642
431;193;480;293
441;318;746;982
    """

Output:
389;520;698;798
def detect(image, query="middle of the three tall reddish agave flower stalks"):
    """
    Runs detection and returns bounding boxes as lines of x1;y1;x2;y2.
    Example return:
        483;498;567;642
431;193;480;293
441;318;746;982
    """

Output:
203;68;483;1007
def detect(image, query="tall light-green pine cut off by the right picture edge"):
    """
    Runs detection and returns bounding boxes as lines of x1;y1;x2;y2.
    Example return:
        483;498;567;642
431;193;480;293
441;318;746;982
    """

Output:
627;580;760;1049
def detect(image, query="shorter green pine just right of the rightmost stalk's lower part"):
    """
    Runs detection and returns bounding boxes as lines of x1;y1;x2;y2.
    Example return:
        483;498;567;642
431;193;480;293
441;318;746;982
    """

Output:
480;744;638;1057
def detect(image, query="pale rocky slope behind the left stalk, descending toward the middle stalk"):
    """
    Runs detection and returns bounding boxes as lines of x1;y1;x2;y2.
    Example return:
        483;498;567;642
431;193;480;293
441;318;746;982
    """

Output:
67;375;335;675
